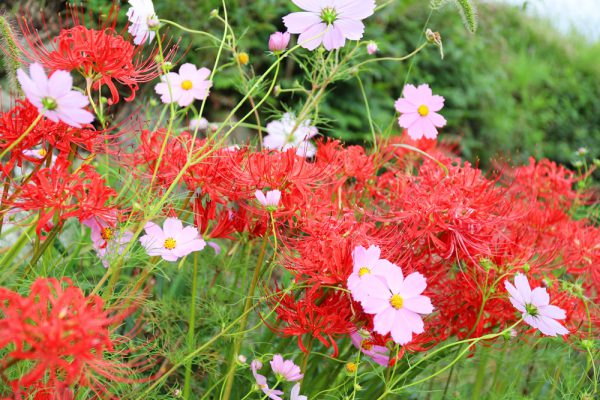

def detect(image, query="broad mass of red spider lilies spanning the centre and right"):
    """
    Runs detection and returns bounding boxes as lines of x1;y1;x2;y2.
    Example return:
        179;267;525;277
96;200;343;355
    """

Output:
132;133;600;360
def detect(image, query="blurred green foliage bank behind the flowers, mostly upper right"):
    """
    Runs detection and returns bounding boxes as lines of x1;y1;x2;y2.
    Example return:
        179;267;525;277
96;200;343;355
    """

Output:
1;0;600;167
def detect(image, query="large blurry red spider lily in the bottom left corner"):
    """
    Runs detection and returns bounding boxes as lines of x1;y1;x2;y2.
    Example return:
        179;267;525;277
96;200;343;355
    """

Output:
0;278;138;399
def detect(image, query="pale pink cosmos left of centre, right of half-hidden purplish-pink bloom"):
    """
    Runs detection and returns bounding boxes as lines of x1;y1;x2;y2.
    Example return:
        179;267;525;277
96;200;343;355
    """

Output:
140;218;206;261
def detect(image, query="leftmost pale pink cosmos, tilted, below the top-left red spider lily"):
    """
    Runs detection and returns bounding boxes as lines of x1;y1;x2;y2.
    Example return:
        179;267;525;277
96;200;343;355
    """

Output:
17;63;94;128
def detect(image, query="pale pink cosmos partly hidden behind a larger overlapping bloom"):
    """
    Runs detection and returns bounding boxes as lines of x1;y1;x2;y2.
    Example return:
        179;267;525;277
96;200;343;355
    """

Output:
348;246;398;301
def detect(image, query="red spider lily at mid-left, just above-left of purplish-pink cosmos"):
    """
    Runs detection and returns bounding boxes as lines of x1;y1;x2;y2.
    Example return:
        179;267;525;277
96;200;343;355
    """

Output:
11;161;117;236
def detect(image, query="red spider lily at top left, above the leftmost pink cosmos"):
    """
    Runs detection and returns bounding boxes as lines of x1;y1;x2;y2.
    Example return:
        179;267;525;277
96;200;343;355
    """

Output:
16;7;175;104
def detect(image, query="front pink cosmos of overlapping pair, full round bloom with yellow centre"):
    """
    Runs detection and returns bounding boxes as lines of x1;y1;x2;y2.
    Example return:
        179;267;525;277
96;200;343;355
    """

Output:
361;267;433;345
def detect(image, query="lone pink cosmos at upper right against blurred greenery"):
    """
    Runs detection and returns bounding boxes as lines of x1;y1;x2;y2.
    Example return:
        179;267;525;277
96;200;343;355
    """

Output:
396;84;446;140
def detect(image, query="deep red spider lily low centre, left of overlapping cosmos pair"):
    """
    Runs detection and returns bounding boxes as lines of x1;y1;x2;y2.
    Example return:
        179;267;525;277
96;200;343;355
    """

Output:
269;288;356;357
